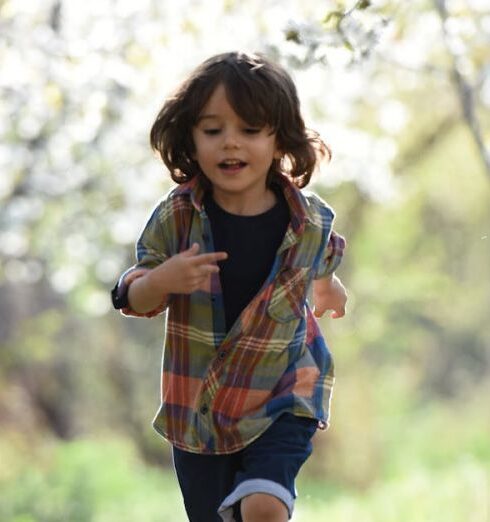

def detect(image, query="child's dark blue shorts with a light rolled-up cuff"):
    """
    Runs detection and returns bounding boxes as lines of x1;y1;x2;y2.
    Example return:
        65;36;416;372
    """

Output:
173;413;317;522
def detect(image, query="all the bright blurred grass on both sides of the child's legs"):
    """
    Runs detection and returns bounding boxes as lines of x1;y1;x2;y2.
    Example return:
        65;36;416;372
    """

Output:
0;428;490;522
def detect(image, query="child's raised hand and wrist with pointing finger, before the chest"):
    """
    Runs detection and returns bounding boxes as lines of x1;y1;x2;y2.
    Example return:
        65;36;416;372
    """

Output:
147;243;228;294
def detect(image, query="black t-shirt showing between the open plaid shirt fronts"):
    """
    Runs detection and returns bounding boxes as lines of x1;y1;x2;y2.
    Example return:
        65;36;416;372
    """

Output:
204;187;290;330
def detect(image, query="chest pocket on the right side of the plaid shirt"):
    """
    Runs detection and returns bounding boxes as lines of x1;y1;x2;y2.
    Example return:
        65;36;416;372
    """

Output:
267;267;309;323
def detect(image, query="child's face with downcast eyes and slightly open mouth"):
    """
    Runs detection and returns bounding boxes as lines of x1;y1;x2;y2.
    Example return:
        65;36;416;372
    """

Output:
192;85;282;208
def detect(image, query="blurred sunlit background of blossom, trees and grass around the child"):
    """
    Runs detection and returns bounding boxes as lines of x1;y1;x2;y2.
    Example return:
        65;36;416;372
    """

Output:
0;0;490;522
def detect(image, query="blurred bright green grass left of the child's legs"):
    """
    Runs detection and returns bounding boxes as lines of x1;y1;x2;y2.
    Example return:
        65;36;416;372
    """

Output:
0;436;185;522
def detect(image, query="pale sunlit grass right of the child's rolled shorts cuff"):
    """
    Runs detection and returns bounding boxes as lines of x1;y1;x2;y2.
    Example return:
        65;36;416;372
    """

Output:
294;458;490;522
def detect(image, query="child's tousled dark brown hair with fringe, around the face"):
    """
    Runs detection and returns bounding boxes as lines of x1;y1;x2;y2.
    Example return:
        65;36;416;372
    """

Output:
150;52;331;188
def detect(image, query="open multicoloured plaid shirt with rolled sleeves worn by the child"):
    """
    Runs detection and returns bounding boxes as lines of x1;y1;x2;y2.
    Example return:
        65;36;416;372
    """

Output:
115;176;345;454
